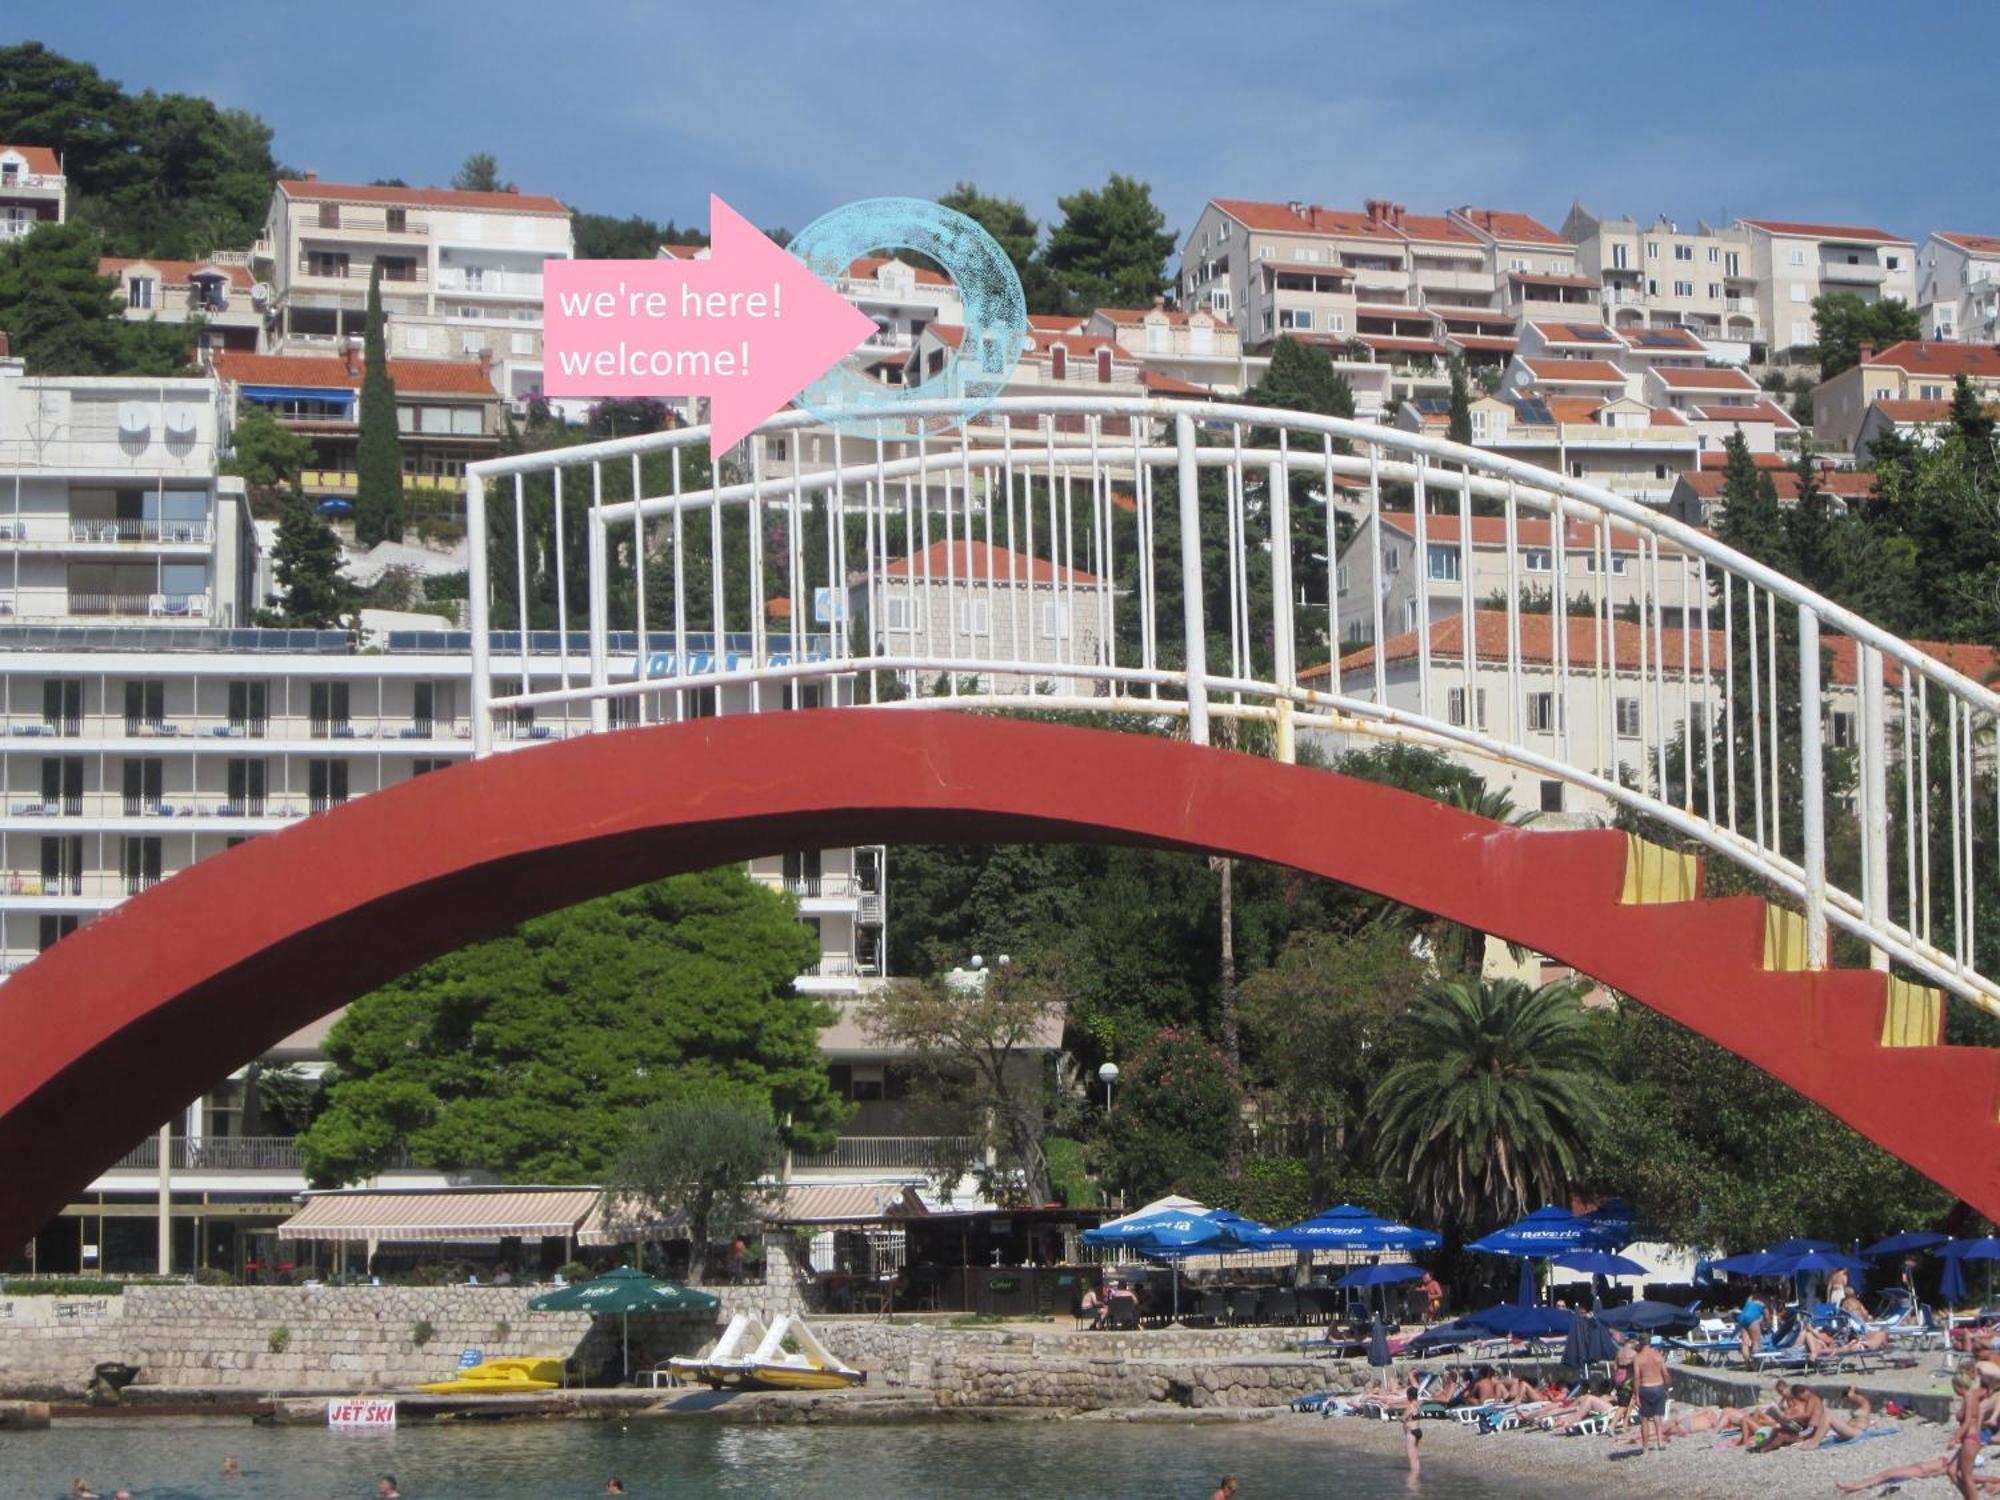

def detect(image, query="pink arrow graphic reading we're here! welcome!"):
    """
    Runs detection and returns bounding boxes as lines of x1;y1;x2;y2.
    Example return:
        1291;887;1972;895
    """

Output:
542;194;876;452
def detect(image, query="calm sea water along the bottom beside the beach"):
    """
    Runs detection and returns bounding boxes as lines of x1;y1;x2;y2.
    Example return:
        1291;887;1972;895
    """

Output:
0;1418;1546;1500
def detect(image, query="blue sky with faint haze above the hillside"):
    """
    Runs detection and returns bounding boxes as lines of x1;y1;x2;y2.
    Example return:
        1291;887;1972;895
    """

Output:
0;0;2000;251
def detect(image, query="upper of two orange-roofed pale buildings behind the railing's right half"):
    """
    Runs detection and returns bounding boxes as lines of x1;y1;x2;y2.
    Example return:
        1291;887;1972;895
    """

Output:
1334;512;1682;648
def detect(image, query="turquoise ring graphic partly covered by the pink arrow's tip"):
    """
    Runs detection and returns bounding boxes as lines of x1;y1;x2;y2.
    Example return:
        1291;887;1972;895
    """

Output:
786;198;1028;436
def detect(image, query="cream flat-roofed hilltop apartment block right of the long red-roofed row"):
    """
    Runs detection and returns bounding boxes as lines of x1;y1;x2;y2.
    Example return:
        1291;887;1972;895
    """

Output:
1562;204;1766;364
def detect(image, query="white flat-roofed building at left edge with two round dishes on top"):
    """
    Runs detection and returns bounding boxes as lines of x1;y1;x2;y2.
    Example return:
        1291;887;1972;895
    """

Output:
0;358;254;626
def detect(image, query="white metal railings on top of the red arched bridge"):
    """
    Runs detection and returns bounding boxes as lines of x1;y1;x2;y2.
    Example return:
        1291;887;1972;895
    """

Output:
468;396;2000;1014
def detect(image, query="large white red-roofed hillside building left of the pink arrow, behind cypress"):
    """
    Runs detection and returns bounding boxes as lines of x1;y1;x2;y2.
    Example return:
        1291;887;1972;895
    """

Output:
252;174;576;404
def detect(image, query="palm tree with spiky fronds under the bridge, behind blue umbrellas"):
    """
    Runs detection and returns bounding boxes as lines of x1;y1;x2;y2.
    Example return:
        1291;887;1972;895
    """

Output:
1368;980;1606;1228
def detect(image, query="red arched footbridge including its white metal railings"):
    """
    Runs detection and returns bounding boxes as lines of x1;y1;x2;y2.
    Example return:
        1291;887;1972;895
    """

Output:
0;398;2000;1242
